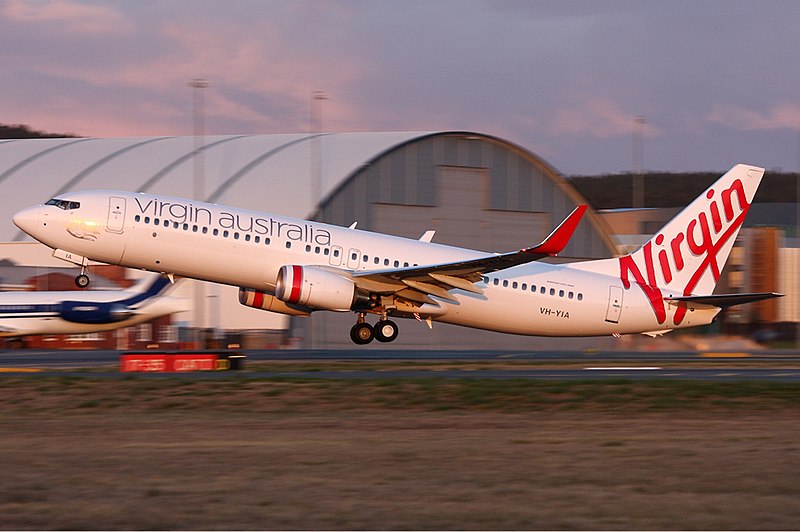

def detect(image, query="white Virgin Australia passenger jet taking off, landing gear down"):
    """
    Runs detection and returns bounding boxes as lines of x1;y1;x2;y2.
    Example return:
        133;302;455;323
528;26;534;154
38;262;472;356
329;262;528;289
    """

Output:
13;165;781;344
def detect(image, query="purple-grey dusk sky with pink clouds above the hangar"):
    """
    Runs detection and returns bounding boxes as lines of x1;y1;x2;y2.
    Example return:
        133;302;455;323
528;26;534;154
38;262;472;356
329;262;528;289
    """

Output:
0;0;800;175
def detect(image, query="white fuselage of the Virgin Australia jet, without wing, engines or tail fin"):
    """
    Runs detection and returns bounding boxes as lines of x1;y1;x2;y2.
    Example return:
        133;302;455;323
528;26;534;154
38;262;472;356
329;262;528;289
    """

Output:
14;191;719;336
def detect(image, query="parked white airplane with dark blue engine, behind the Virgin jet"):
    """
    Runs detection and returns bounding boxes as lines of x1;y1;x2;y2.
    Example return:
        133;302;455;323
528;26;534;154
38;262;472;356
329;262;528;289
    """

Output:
0;275;188;338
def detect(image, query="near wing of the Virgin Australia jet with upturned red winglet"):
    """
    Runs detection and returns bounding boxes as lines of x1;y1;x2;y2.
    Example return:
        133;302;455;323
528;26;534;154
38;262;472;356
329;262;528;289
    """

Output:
353;205;586;303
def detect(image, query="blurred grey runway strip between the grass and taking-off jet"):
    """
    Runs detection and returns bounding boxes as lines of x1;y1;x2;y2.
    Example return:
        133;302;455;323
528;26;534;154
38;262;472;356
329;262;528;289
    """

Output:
0;350;800;382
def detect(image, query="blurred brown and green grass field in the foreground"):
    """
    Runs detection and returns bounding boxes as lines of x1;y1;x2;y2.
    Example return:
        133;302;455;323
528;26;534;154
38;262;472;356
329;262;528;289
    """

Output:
0;376;800;529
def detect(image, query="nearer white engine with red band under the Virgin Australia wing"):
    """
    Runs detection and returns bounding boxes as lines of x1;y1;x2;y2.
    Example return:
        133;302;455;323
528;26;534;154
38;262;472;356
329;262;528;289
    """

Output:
275;265;369;310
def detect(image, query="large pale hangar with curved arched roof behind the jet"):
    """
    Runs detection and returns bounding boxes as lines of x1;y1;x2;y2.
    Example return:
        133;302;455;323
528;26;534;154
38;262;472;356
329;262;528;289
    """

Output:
0;132;615;257
